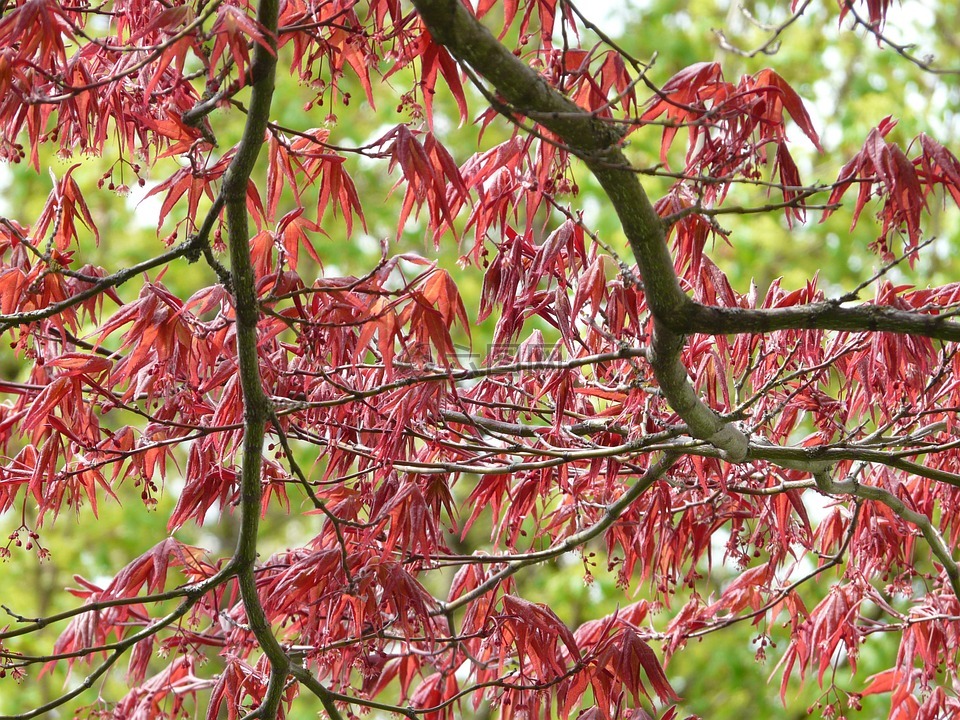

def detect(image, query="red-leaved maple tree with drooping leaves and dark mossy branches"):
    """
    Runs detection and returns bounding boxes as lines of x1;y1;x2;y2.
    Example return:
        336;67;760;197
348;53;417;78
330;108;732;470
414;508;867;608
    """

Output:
0;0;960;720
